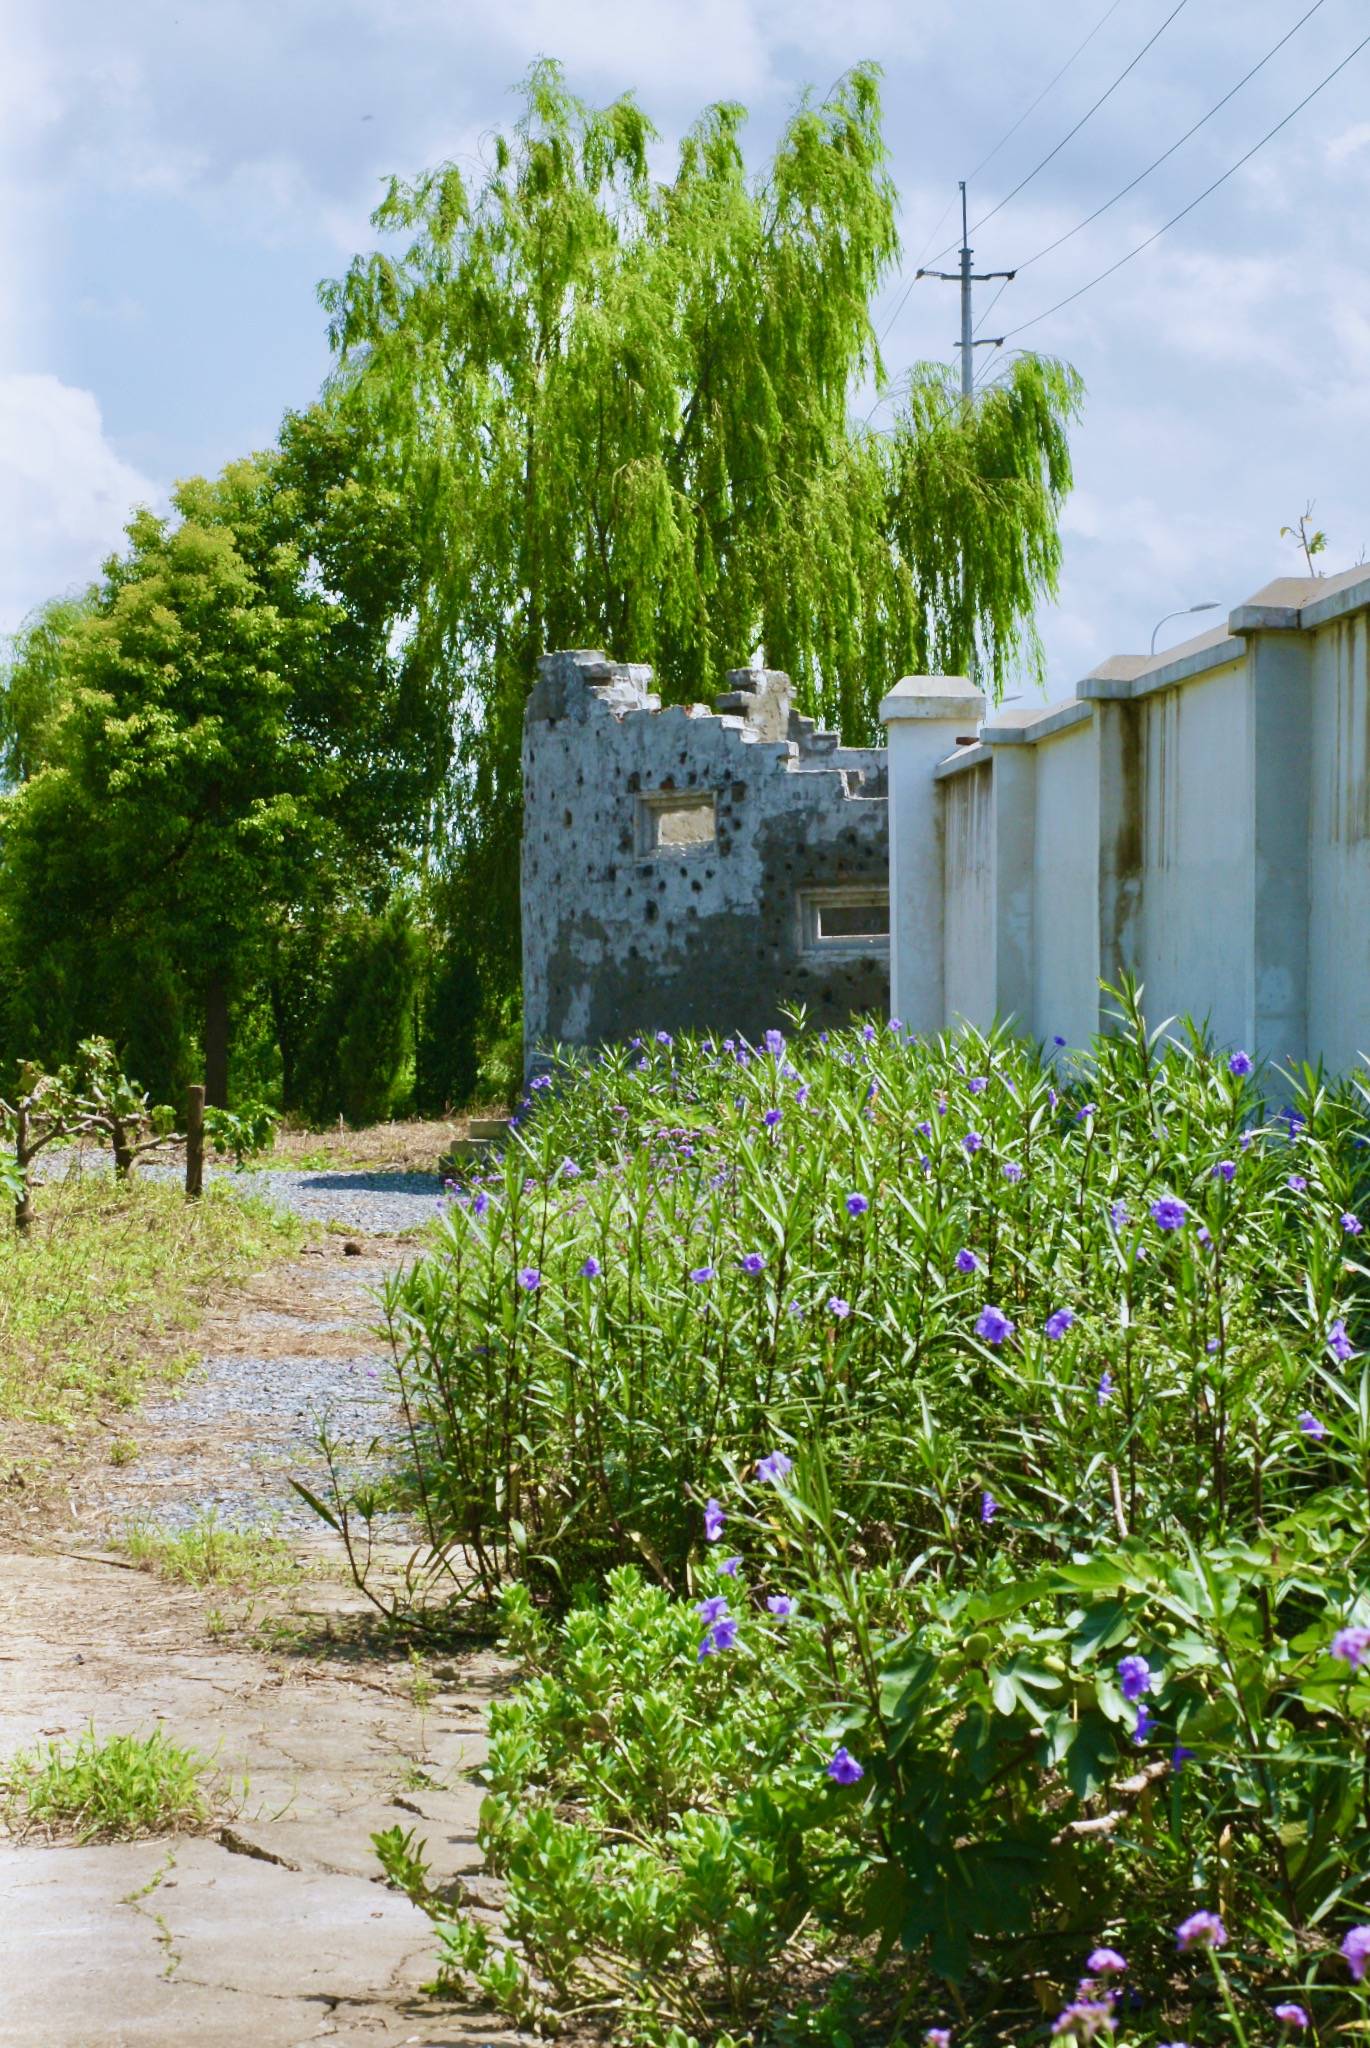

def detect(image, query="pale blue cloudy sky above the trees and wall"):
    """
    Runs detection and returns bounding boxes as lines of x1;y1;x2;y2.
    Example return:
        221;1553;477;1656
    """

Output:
0;0;1370;696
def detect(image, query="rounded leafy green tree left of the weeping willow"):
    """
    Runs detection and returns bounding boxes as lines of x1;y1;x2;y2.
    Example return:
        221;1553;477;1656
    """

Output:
0;454;448;1104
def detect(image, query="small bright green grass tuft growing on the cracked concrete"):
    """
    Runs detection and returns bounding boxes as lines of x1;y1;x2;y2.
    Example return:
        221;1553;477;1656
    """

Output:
0;1729;209;1841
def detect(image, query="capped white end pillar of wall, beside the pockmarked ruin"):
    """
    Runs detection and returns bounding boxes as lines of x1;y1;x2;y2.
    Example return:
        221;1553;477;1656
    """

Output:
881;676;985;1034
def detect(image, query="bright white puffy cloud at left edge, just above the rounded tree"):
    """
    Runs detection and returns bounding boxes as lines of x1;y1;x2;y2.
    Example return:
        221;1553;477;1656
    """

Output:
0;375;162;633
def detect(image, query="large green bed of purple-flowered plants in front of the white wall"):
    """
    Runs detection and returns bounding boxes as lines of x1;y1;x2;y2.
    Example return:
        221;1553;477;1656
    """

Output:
344;993;1370;2042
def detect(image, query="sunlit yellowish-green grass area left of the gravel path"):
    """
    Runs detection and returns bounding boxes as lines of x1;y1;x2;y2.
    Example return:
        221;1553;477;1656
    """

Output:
0;1176;303;1427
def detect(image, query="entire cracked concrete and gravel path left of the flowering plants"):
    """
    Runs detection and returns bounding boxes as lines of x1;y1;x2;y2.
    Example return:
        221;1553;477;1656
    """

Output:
0;1196;516;2048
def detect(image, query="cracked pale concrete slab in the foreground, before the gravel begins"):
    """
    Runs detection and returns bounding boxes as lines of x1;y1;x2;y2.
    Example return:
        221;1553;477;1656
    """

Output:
0;1552;516;2048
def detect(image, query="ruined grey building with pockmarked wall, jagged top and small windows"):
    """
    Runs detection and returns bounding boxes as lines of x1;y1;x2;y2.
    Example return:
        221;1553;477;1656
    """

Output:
522;651;889;1053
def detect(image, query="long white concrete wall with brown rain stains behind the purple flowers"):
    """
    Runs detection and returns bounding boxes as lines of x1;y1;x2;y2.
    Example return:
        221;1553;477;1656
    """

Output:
891;569;1370;1071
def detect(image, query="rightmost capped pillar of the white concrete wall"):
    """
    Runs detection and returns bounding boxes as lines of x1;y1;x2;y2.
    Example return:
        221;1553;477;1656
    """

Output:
1231;606;1313;1065
